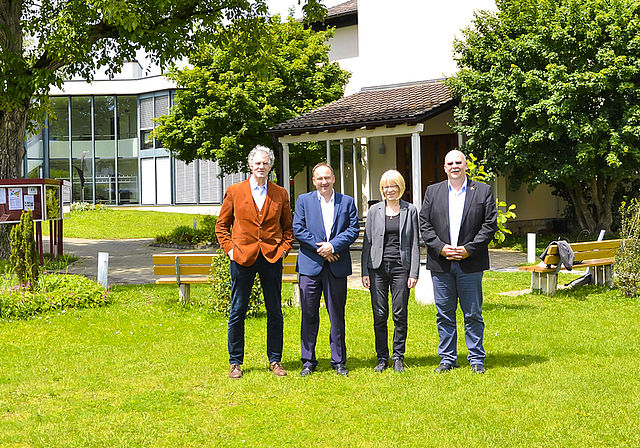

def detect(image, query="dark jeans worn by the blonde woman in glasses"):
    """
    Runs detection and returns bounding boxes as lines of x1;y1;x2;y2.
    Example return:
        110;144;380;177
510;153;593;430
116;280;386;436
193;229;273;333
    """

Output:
369;261;409;361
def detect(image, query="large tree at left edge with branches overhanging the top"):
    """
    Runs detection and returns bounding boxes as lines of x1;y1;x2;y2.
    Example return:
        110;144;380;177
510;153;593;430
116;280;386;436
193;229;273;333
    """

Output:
0;0;326;258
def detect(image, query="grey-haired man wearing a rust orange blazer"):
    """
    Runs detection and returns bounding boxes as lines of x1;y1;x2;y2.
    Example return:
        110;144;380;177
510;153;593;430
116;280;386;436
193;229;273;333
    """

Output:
216;146;293;378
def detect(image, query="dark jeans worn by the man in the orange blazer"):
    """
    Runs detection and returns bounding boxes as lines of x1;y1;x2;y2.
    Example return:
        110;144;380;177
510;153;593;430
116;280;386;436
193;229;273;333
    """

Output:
227;253;284;364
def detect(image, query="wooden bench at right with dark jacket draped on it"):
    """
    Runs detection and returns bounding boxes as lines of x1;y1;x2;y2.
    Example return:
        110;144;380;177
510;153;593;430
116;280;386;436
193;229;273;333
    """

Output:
519;240;622;296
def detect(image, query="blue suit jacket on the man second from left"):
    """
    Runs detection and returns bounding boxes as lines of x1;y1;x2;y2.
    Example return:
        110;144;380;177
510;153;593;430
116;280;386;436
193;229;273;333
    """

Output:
293;190;360;277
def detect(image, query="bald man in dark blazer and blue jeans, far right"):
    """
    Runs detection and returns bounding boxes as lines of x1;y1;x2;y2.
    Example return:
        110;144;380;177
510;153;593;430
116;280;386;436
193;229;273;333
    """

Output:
420;150;498;373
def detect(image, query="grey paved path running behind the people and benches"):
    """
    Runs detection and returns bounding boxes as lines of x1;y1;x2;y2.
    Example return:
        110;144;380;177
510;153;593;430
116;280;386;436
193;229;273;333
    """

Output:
50;238;527;288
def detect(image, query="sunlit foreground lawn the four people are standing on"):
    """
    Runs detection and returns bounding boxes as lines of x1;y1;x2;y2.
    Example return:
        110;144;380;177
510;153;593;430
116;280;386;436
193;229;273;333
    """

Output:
0;272;640;447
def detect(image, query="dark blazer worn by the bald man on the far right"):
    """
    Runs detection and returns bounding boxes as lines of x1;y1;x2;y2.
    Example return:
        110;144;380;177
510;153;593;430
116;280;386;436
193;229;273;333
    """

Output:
420;178;498;272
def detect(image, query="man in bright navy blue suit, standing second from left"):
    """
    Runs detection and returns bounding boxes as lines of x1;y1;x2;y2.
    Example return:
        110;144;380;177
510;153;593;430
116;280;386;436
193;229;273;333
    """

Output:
293;163;360;376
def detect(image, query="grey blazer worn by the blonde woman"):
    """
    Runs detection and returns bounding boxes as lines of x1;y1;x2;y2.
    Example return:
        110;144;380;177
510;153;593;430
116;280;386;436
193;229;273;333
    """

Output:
361;199;420;278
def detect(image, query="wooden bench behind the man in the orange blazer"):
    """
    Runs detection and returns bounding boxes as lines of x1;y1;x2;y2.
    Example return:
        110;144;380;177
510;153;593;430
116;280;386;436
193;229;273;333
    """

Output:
153;253;300;306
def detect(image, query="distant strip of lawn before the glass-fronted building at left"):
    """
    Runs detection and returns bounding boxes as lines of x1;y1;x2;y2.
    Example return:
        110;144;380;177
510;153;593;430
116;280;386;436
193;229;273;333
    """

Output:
42;208;205;240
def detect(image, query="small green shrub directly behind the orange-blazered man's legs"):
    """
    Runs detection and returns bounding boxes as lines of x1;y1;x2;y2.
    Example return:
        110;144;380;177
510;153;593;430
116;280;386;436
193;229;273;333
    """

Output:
203;250;264;317
